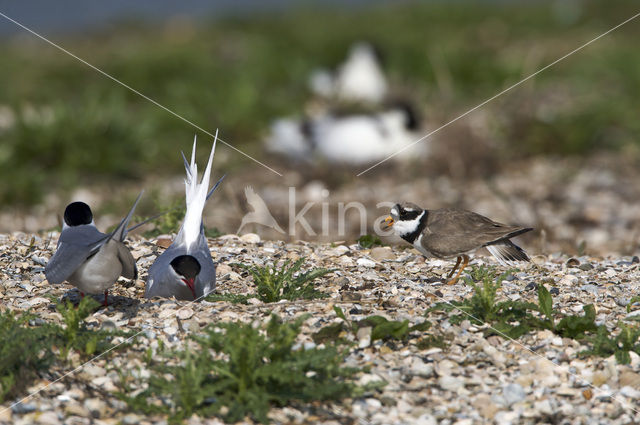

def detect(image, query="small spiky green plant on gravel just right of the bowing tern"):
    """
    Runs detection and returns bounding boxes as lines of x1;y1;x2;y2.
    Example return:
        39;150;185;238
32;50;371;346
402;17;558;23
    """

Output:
238;257;333;303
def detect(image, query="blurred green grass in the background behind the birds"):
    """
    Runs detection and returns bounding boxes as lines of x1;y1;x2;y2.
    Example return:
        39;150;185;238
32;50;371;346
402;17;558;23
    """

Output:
0;0;640;206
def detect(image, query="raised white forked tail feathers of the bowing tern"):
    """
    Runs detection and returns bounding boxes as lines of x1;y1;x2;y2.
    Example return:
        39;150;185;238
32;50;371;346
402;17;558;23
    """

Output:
177;131;218;252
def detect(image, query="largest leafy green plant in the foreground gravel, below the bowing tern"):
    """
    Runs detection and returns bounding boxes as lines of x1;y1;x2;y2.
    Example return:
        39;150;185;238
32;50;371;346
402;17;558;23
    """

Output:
120;315;358;423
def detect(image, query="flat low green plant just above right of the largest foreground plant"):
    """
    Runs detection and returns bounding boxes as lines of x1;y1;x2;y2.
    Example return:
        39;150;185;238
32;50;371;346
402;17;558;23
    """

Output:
312;306;431;344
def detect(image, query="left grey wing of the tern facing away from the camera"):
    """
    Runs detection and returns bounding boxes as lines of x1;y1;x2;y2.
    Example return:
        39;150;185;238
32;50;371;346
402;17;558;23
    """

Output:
44;225;108;284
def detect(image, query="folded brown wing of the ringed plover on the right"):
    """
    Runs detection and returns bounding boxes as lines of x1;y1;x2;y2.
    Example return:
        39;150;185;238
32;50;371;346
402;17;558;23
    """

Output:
421;209;532;257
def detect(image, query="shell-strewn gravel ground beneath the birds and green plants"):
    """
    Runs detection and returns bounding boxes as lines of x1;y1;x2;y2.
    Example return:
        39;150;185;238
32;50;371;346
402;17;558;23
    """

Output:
0;233;640;425
